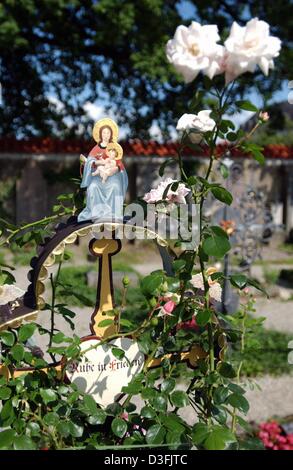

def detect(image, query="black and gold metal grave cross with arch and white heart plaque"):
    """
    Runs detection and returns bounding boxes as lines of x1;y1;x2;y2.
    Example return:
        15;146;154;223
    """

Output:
0;220;206;406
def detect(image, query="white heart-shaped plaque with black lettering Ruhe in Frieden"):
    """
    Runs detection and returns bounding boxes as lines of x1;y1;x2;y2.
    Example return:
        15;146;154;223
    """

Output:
66;338;144;407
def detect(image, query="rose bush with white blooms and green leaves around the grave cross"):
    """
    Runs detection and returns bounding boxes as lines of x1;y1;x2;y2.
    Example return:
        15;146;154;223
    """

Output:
0;19;280;450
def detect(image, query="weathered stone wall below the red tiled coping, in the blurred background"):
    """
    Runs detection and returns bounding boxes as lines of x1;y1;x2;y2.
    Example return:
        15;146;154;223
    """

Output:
0;154;293;232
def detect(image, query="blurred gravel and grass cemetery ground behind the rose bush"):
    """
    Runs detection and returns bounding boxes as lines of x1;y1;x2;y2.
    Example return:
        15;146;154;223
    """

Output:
4;236;293;423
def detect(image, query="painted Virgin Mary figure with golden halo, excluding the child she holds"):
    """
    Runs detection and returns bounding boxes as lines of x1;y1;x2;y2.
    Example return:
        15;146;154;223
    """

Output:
78;118;128;222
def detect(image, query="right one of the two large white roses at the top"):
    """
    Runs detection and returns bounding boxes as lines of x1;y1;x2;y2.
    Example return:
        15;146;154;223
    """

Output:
225;18;281;83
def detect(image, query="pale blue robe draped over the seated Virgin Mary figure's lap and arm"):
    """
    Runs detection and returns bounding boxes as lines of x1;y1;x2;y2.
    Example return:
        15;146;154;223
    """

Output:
77;157;128;222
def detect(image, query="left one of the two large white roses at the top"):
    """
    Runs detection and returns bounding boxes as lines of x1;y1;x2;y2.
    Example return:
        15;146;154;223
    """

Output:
166;21;225;83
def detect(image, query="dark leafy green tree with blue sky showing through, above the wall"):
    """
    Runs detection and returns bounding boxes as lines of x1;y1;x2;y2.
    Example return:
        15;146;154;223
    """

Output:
0;0;293;137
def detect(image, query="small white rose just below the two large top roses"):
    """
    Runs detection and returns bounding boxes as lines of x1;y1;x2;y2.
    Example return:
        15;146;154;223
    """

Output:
176;109;216;143
